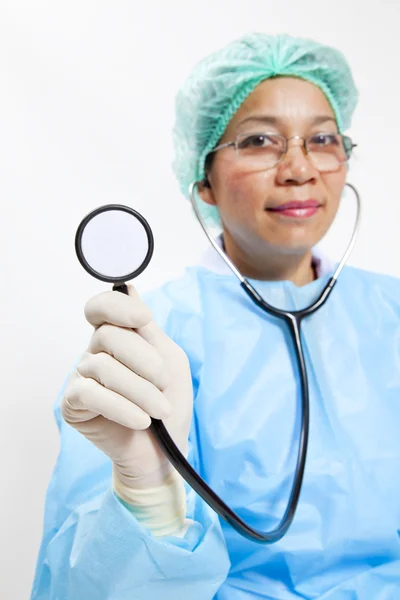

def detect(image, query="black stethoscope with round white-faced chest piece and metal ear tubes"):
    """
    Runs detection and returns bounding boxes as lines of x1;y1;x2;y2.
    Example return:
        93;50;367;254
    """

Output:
75;182;361;544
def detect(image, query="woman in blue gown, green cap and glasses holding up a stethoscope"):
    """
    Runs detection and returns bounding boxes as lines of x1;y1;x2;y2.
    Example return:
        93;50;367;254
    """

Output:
32;34;400;600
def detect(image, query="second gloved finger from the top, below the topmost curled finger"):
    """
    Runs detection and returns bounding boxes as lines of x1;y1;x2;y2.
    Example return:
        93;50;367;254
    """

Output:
88;324;167;391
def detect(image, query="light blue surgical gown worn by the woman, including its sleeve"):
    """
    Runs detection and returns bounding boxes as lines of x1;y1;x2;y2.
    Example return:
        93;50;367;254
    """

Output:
32;267;400;600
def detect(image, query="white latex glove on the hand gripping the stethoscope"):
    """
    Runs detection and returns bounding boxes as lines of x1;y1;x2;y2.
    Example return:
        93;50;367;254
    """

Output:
61;285;193;536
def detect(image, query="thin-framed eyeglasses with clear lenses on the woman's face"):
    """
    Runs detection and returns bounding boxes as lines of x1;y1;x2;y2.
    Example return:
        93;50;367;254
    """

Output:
209;133;357;172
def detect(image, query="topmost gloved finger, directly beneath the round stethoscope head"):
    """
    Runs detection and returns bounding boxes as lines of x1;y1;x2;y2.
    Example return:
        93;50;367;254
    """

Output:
84;285;151;329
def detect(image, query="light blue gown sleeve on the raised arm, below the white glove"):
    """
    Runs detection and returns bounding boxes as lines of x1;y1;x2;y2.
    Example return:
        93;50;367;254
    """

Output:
31;318;230;600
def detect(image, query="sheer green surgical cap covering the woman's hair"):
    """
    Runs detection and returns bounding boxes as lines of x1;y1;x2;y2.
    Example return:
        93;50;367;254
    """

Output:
173;33;358;216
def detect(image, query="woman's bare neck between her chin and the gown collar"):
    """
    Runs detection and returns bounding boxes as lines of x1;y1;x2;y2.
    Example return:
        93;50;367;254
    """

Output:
223;232;316;287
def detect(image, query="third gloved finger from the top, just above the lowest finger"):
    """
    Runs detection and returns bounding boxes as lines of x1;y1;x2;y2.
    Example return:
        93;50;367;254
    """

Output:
77;352;171;419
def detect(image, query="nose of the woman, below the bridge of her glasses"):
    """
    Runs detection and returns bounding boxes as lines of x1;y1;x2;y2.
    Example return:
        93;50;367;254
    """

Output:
277;140;318;185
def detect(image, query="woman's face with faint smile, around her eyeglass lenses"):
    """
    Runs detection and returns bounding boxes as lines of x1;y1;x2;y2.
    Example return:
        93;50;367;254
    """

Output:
199;77;347;256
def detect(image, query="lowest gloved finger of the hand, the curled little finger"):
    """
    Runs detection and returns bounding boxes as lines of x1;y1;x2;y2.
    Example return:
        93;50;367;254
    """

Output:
62;372;151;429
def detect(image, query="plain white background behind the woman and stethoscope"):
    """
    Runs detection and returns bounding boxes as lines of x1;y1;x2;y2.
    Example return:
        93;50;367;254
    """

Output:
0;0;400;600
